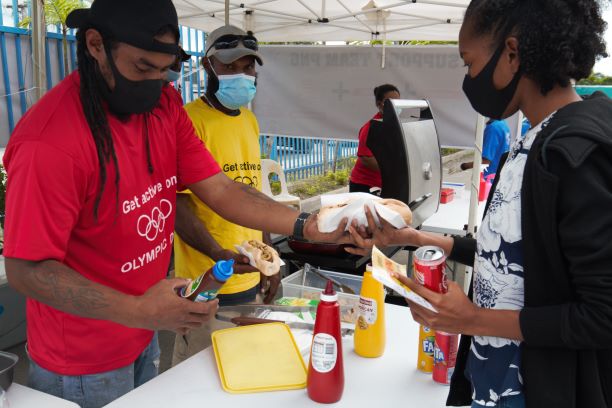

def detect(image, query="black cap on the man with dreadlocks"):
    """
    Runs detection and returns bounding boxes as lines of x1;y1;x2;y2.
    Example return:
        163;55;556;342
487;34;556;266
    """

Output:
66;0;179;55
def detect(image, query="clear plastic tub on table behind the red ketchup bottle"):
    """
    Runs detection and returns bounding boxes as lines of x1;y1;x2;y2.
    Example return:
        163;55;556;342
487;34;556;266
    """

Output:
281;269;363;323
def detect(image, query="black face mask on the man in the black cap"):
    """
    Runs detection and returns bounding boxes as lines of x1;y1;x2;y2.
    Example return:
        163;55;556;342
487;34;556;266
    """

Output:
100;48;164;115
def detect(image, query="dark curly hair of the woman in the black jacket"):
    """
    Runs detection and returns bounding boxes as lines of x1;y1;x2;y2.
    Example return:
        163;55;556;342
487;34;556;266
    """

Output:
464;0;607;95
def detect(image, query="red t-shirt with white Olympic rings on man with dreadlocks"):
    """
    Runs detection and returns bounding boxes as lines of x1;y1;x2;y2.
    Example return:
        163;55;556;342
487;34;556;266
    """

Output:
4;72;220;375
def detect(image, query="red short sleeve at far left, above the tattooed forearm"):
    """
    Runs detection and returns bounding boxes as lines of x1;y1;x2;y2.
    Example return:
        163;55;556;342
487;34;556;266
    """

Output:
4;141;87;261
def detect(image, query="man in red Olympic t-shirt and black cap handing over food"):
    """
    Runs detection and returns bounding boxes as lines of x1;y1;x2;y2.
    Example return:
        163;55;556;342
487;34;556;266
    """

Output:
4;0;343;407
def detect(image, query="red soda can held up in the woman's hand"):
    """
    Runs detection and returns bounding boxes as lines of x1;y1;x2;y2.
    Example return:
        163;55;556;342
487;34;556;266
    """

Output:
414;246;448;293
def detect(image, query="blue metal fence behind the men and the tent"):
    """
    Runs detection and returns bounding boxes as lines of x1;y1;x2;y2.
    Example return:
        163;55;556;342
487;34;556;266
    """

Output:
0;0;357;181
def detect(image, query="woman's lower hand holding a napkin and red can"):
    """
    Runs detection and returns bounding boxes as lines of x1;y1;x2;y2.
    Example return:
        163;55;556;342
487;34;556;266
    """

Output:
394;274;482;335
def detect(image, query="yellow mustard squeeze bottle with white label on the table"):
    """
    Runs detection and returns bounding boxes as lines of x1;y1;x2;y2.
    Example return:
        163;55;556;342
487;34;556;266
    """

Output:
354;265;386;358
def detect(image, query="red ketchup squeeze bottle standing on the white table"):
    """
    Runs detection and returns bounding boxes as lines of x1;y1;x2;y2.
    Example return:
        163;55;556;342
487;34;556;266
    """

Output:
307;281;344;404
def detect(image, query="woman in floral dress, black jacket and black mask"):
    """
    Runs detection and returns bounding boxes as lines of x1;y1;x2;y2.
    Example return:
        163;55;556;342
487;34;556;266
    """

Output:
349;0;612;408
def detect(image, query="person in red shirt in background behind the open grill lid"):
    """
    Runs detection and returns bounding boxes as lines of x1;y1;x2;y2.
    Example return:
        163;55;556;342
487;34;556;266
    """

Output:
349;84;400;193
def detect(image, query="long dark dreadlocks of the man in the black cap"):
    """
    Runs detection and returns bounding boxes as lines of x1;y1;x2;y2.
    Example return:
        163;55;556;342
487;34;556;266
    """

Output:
76;28;120;218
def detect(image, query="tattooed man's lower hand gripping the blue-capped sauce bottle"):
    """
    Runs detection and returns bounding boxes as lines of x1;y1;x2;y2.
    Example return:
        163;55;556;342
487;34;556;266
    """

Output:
130;279;219;334
